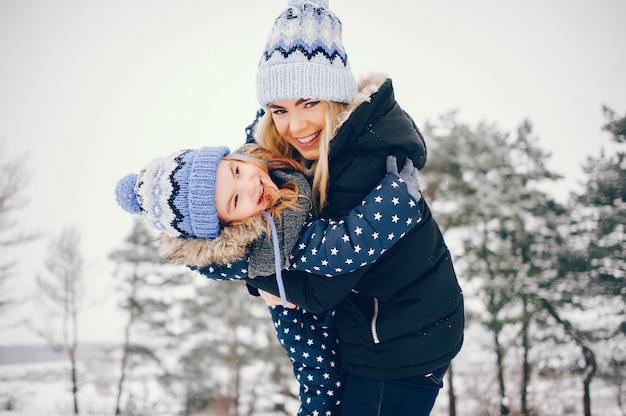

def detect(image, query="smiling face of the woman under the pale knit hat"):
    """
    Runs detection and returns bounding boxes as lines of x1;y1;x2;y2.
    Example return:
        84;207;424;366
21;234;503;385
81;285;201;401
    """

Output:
268;100;328;160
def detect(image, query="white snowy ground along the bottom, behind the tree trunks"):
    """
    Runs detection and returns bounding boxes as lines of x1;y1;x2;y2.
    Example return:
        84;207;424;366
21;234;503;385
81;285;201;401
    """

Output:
0;324;623;416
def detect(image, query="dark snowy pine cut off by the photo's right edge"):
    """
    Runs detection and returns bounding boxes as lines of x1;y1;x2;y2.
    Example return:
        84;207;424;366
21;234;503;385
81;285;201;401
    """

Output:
560;107;626;414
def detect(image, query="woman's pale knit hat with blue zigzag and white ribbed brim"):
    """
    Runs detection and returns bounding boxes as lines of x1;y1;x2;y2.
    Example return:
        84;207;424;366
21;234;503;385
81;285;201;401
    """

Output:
257;0;357;106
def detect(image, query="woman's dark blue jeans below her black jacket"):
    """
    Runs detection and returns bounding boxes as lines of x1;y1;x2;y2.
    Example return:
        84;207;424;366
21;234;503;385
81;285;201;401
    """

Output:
341;364;449;416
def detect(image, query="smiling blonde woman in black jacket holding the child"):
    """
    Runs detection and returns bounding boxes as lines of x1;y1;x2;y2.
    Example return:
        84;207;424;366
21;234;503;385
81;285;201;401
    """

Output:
241;0;464;416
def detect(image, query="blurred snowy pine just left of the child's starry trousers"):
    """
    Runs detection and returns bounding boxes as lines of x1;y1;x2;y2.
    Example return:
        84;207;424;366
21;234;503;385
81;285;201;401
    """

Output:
176;274;294;415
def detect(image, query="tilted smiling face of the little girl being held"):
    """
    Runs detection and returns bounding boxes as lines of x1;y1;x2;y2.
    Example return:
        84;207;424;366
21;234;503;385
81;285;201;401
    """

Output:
215;159;278;224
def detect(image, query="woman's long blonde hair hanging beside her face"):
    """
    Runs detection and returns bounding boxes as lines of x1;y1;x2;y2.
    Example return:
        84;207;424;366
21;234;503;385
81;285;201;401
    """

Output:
254;101;347;214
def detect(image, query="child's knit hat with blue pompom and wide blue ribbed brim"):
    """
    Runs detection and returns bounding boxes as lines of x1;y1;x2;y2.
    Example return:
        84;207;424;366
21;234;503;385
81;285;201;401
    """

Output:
115;147;230;238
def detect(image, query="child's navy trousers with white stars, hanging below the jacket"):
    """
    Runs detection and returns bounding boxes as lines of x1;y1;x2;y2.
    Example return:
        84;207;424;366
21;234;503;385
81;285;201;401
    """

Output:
269;306;343;416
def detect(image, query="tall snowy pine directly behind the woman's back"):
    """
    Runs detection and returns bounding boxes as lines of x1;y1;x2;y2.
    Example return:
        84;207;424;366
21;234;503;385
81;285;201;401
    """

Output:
425;113;566;414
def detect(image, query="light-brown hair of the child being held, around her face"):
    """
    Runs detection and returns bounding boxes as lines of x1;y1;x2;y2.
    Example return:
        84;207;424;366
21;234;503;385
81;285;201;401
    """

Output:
224;145;309;228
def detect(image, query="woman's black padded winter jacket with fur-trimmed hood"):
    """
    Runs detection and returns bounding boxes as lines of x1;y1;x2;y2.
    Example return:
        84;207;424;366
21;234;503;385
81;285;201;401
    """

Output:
249;75;464;379
